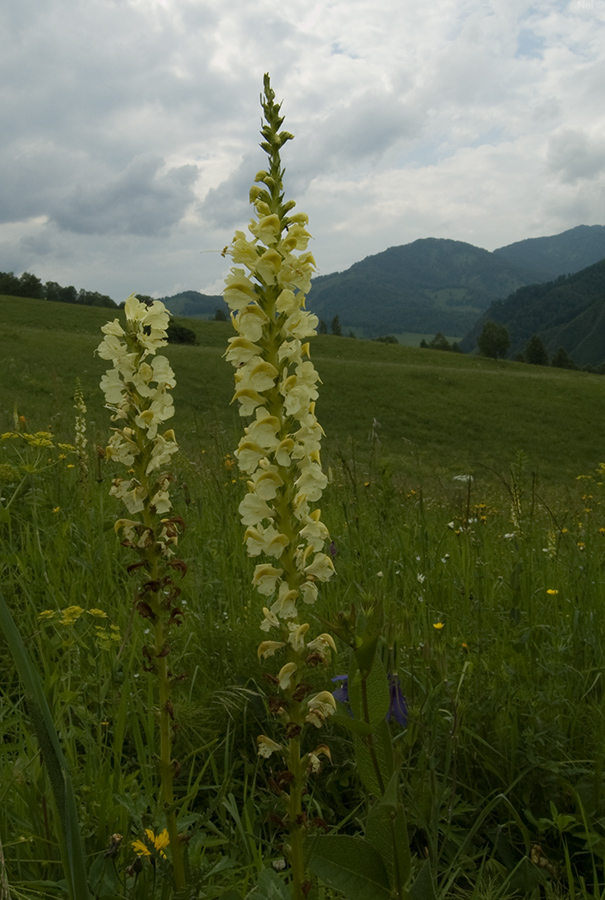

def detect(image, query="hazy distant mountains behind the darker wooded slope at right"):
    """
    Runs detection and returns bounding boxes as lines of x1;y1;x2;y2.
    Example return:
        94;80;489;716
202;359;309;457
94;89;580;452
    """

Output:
162;225;605;337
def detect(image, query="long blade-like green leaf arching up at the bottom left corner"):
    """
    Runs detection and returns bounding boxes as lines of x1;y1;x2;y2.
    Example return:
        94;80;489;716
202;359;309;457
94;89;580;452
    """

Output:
0;593;90;900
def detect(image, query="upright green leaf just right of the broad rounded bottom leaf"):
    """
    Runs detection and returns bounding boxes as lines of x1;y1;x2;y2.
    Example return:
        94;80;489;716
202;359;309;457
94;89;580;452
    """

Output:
366;772;411;889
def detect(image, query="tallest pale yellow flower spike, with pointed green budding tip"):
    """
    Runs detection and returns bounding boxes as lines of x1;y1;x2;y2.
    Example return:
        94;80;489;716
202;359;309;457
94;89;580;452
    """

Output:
224;75;336;900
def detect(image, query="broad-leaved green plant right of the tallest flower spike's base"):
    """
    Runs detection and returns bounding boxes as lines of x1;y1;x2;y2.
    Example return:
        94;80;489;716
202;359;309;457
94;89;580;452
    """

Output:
311;602;416;900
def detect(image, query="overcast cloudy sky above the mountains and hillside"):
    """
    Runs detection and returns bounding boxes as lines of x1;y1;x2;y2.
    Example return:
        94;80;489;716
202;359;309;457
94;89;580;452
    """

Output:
0;0;605;301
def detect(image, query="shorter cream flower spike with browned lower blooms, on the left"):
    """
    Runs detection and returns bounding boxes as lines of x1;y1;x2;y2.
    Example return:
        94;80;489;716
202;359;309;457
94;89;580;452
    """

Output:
97;294;186;891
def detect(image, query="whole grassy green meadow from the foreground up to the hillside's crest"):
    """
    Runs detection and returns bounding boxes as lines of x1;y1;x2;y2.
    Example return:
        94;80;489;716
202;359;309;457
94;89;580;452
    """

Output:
0;299;605;900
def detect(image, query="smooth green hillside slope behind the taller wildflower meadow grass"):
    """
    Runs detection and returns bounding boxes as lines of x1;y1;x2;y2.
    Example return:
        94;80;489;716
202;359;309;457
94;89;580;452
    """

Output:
0;297;605;482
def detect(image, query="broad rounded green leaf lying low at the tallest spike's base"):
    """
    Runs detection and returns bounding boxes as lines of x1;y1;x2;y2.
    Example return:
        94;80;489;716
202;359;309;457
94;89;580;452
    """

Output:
309;834;391;900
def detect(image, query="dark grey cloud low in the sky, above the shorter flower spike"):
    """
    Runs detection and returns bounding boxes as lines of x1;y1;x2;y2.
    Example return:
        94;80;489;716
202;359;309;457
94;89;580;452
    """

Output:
52;154;197;236
